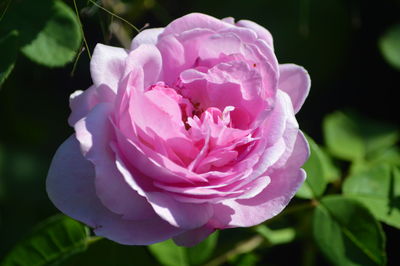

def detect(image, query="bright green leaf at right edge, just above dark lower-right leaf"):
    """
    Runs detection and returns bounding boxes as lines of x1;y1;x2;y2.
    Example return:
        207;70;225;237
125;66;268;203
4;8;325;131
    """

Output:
343;164;400;229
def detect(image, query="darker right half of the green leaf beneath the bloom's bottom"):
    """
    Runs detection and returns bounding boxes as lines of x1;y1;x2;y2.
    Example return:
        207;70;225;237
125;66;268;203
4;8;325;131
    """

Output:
185;231;219;265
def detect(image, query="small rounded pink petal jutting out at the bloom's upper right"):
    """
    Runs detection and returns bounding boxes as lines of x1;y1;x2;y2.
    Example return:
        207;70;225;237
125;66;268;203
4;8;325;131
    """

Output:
278;64;311;113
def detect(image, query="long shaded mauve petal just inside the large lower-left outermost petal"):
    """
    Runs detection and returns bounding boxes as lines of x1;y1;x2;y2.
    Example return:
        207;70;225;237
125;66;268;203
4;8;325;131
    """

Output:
75;104;154;220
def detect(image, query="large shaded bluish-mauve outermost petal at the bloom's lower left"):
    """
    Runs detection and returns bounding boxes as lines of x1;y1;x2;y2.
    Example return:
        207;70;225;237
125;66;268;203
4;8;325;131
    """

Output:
46;135;184;245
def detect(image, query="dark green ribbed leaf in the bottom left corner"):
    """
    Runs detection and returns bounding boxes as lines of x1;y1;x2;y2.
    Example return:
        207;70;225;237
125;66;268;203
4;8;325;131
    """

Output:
0;215;89;266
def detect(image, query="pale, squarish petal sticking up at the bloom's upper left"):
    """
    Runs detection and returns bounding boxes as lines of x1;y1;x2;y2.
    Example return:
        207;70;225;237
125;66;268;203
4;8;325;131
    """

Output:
90;43;128;89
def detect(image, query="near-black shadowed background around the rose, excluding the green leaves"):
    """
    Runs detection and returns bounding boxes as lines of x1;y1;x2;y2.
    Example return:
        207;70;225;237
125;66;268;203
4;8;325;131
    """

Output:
0;0;400;265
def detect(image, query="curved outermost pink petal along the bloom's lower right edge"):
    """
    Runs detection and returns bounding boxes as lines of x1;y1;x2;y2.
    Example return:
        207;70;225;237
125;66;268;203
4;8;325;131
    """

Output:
213;133;309;227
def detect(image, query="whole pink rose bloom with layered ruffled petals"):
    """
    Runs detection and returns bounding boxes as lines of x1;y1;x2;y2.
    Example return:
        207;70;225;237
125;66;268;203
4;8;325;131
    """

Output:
47;11;310;246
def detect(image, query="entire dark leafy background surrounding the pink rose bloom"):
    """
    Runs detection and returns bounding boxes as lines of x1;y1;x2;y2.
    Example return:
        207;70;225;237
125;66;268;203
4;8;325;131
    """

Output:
0;0;400;266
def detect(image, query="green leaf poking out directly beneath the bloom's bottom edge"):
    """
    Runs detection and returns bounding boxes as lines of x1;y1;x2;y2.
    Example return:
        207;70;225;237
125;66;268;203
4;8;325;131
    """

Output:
148;232;218;266
